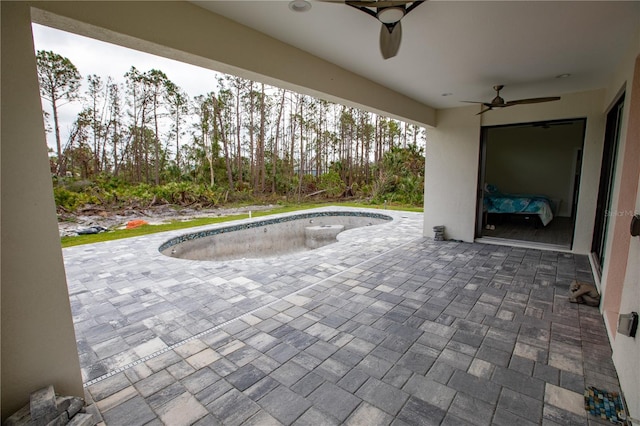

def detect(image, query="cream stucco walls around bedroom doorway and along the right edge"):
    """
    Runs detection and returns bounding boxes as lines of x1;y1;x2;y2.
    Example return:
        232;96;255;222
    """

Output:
424;36;640;418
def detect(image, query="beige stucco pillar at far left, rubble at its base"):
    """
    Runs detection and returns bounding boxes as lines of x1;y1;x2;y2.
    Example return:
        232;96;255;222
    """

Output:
0;1;84;420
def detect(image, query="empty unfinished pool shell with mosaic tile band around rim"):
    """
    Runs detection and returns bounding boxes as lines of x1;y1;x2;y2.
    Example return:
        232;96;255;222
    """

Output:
158;211;393;260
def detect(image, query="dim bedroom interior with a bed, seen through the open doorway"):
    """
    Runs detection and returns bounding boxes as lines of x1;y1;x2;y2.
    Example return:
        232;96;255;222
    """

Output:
478;119;586;249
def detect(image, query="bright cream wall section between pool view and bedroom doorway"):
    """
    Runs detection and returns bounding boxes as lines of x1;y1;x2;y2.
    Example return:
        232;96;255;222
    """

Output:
423;107;480;241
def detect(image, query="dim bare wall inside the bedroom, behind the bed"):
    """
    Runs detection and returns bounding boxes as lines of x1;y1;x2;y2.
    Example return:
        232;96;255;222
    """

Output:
485;121;584;217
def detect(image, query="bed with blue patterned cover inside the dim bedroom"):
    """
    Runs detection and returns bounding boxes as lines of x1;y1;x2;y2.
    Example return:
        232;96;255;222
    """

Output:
484;185;553;226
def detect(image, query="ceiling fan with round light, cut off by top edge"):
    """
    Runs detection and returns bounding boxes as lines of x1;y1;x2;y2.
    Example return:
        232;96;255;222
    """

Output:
345;0;425;59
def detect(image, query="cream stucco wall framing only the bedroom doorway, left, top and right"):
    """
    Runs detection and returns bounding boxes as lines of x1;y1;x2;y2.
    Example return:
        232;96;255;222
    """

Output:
424;90;605;254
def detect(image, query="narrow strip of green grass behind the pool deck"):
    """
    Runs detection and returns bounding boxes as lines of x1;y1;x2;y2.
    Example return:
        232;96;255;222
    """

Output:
60;202;423;248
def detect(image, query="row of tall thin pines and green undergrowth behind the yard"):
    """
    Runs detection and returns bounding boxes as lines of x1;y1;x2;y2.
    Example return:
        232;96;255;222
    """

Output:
39;52;426;206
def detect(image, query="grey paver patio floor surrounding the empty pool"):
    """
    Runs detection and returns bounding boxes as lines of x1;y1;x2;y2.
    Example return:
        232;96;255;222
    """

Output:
64;208;619;426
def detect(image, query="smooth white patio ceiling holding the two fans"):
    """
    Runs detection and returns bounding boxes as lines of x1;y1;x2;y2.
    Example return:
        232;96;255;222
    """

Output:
193;0;640;108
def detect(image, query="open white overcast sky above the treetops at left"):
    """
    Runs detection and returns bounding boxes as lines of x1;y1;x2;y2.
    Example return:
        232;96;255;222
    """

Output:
32;24;220;148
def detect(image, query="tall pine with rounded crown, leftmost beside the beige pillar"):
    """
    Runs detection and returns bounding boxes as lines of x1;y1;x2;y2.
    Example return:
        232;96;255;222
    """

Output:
36;50;82;175
